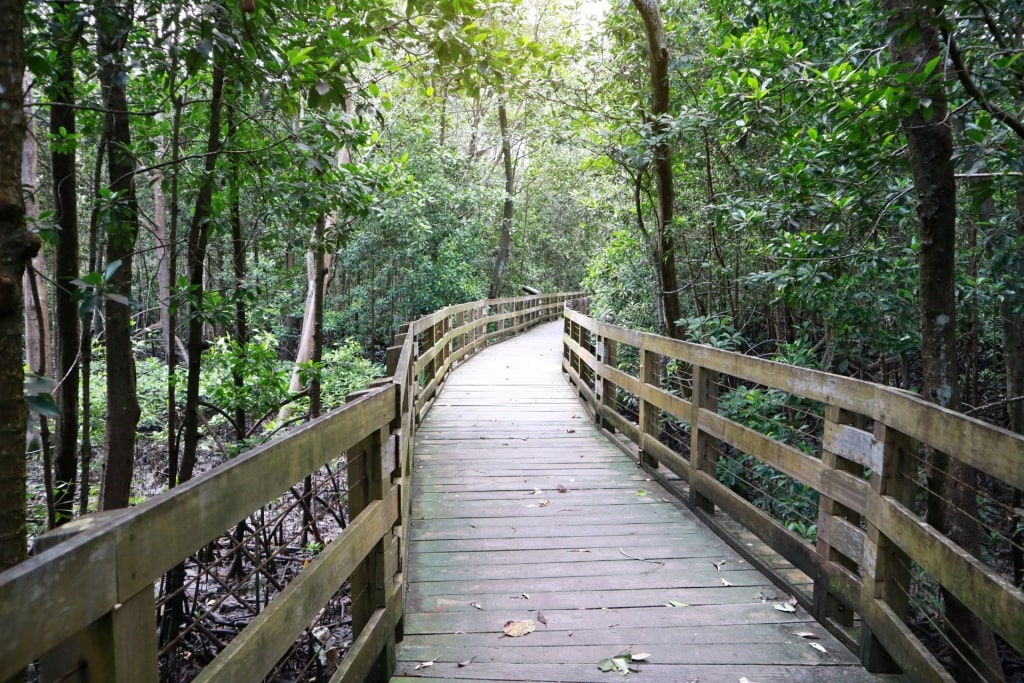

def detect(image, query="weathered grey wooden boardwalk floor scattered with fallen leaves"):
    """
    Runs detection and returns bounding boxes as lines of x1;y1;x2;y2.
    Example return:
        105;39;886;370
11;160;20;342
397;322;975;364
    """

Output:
392;323;889;683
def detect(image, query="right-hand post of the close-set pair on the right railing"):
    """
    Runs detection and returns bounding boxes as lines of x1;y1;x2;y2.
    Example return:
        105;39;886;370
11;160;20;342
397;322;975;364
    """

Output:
860;421;918;673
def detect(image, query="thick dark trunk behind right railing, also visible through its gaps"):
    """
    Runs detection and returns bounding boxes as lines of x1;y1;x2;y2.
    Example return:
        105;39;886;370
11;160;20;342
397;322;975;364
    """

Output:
883;0;1002;682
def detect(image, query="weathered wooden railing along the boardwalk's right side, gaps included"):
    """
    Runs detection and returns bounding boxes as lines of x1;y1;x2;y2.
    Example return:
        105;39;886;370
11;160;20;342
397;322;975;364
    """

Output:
563;300;1024;681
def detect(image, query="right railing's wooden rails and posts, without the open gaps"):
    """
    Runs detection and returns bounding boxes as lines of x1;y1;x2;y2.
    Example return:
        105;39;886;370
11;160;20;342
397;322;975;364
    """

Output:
563;305;1024;681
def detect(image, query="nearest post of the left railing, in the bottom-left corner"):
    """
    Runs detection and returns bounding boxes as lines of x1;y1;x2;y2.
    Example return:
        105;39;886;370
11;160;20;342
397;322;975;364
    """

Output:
35;508;159;683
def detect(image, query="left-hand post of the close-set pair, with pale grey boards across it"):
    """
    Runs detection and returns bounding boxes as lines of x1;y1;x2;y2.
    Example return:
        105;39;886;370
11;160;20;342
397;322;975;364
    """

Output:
814;405;869;627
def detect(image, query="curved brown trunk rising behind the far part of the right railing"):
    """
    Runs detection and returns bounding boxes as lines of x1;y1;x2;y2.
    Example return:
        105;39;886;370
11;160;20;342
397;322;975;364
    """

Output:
633;0;682;337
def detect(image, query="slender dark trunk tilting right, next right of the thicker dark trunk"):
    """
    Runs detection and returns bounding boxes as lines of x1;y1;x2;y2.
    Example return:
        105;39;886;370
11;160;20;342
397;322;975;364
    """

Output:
178;42;225;482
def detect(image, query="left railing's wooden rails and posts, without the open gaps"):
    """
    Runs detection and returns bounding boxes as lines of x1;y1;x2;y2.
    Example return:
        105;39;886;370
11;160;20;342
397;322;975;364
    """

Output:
0;293;578;683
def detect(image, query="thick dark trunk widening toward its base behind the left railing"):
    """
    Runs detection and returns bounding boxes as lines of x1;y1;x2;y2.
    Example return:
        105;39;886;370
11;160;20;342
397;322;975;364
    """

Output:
96;0;139;510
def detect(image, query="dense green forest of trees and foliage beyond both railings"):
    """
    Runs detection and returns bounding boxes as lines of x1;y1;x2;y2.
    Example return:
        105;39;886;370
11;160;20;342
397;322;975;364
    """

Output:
0;0;1024;667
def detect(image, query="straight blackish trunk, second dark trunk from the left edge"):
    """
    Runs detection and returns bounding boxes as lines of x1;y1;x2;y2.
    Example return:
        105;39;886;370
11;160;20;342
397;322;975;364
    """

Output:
50;0;82;523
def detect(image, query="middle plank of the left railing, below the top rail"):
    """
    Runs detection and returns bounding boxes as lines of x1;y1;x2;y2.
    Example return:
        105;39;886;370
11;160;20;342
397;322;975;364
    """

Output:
196;486;398;683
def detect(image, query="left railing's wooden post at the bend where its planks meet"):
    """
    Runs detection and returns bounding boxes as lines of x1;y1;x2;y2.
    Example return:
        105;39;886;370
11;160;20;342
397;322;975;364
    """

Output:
346;427;401;681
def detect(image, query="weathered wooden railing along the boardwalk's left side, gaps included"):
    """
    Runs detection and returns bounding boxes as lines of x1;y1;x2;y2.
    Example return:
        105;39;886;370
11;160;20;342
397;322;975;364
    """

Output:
0;294;571;683
